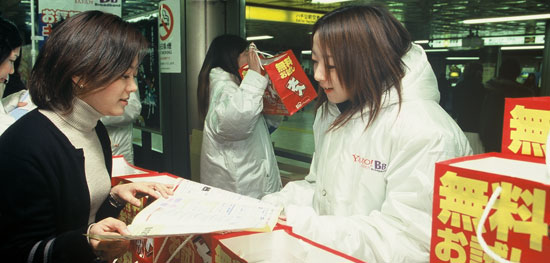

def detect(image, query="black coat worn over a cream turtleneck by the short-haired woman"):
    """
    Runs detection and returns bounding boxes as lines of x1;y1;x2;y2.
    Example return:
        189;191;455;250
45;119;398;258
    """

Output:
0;110;119;263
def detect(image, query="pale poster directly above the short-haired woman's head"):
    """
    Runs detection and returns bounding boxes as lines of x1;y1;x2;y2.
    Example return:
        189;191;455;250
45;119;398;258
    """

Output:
37;0;122;46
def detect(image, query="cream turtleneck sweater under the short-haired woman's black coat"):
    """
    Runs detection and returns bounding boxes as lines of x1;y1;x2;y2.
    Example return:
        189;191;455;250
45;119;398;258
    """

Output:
39;98;111;224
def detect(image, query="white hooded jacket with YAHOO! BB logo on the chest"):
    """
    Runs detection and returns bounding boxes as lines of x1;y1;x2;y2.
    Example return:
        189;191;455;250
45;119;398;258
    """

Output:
263;45;472;262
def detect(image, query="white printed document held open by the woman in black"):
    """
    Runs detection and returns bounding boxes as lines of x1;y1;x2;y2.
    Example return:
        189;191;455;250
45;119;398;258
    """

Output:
90;179;282;239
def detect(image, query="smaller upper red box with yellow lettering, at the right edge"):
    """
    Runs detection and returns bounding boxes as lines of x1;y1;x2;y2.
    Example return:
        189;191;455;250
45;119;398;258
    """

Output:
501;97;550;158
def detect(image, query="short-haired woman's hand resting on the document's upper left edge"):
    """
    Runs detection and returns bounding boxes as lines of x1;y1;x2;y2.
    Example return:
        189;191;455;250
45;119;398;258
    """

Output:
111;182;174;206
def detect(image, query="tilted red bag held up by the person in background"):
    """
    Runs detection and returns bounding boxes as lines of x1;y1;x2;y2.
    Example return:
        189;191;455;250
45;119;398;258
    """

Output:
239;50;317;115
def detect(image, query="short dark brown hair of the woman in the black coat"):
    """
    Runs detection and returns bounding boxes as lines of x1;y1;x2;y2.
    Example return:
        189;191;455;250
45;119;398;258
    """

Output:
28;11;148;113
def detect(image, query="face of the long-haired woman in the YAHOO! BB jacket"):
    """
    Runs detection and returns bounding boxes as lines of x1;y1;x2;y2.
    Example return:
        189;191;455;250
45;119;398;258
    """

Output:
311;34;349;103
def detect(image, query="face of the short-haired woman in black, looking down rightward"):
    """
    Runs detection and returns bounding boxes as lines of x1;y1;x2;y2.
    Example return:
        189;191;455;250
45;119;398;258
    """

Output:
80;58;138;116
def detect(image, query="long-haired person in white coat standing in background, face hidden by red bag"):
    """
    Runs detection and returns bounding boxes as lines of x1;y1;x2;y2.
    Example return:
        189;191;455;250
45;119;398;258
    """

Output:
197;35;281;198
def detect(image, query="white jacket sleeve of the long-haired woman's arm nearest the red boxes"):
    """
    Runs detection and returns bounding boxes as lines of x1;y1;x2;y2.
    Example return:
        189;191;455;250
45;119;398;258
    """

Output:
284;134;470;262
